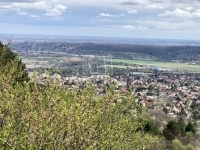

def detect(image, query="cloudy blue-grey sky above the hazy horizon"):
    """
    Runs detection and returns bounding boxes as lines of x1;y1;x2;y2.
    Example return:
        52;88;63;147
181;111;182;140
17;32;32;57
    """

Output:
0;0;200;40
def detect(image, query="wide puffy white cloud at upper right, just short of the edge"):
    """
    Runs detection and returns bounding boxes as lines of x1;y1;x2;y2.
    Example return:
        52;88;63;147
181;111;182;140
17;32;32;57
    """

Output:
158;8;192;18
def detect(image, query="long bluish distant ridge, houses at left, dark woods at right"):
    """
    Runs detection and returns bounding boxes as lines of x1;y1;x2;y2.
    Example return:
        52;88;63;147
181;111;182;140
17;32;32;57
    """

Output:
11;42;200;62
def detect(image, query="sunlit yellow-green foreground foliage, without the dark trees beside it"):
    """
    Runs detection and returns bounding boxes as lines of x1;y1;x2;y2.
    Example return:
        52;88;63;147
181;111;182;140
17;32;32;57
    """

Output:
0;77;162;149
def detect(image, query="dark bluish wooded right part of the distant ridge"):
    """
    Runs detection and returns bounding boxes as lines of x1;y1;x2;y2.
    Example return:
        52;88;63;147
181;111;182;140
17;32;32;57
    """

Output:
72;43;200;62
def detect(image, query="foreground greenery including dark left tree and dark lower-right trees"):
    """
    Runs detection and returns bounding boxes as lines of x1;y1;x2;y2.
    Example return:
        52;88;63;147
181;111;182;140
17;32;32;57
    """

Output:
0;44;195;150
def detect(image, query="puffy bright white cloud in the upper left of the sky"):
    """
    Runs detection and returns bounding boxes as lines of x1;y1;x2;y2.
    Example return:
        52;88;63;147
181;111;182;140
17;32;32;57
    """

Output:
44;4;67;17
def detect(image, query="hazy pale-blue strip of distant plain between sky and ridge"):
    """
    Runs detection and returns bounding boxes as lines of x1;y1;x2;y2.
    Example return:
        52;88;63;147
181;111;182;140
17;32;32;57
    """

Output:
0;33;200;46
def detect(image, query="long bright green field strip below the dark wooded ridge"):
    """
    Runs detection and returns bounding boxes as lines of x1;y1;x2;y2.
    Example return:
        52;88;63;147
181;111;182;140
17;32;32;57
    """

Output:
107;59;200;72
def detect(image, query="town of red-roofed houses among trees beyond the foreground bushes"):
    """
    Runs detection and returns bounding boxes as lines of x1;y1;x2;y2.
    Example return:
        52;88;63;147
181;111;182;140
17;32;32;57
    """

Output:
30;65;200;120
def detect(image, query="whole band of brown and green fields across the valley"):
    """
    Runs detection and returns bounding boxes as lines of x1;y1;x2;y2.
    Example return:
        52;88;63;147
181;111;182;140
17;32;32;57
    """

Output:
20;55;200;72
